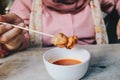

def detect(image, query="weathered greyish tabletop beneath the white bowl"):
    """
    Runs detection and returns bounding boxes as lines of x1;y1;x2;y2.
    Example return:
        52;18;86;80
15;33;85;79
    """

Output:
0;44;120;80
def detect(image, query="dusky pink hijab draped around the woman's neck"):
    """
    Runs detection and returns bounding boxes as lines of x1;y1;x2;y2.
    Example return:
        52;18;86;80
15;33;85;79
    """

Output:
43;0;90;13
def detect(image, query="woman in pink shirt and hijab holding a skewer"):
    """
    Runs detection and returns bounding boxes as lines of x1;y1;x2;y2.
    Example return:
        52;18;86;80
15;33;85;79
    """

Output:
0;0;120;56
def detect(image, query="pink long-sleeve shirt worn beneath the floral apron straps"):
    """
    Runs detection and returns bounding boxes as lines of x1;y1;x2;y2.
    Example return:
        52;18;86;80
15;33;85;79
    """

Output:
10;0;120;45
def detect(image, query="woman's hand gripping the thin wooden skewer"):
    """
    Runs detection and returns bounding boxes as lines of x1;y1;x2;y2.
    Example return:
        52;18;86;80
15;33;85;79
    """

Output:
0;14;26;51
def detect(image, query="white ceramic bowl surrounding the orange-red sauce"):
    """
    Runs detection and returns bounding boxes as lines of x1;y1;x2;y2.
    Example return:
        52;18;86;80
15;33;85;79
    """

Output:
43;47;90;80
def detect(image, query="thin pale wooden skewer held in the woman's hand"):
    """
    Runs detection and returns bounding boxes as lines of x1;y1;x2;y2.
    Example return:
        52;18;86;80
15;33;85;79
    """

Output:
0;22;54;37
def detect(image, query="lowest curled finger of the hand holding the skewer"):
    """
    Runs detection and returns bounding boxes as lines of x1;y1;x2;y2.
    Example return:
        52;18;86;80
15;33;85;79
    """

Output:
5;35;24;50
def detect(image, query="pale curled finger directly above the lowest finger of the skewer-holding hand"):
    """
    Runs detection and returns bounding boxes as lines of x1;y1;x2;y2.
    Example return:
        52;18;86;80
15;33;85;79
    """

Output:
0;28;21;43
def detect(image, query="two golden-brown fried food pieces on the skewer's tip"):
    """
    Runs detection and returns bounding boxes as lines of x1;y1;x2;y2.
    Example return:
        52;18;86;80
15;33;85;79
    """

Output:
52;33;78;49
